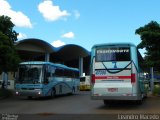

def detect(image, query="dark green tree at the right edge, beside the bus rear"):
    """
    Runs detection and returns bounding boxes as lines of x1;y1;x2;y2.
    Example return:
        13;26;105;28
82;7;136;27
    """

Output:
135;21;160;68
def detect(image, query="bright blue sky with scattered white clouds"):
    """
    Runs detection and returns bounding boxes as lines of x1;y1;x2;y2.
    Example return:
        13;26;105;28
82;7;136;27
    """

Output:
0;0;160;51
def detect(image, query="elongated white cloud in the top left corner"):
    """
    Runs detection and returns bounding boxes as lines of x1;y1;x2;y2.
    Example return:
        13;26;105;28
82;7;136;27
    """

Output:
0;0;32;28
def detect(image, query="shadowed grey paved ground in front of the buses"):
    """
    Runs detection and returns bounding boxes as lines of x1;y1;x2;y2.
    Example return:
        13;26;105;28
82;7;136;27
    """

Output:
0;91;160;119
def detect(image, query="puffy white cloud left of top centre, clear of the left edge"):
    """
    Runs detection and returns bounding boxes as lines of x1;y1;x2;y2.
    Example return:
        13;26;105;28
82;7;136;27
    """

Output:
38;0;70;21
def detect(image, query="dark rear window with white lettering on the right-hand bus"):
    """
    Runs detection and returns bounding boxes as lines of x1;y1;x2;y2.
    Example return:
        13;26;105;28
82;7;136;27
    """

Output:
96;47;131;62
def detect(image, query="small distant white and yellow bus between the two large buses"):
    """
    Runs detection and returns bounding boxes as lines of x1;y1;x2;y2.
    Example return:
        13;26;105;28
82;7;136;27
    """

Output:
80;75;91;91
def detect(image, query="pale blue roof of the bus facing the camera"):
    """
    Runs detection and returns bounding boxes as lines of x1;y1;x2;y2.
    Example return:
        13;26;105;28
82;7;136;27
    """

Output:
20;61;79;71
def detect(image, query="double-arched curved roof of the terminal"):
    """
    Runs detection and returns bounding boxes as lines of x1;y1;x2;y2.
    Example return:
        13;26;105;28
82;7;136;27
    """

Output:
15;38;90;61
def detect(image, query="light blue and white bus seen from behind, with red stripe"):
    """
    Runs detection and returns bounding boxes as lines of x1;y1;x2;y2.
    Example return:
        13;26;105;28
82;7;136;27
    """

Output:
91;43;147;104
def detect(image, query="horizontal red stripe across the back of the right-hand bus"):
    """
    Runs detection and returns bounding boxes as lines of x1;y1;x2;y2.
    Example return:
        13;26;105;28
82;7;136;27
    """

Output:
95;76;131;79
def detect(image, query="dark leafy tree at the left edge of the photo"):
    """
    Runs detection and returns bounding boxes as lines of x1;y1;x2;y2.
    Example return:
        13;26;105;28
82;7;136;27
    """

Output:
0;16;20;74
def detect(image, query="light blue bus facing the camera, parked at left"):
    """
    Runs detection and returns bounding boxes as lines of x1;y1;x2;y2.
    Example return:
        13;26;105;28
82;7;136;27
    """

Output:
15;62;80;98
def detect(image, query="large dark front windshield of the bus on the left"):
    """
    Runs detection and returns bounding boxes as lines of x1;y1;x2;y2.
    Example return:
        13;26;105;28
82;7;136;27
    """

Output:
17;65;43;84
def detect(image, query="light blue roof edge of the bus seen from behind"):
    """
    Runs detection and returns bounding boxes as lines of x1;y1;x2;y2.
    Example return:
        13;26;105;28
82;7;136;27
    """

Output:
92;42;136;48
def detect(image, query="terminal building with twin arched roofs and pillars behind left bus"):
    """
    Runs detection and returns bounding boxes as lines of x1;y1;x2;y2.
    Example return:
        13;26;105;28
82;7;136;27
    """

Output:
0;38;90;89
